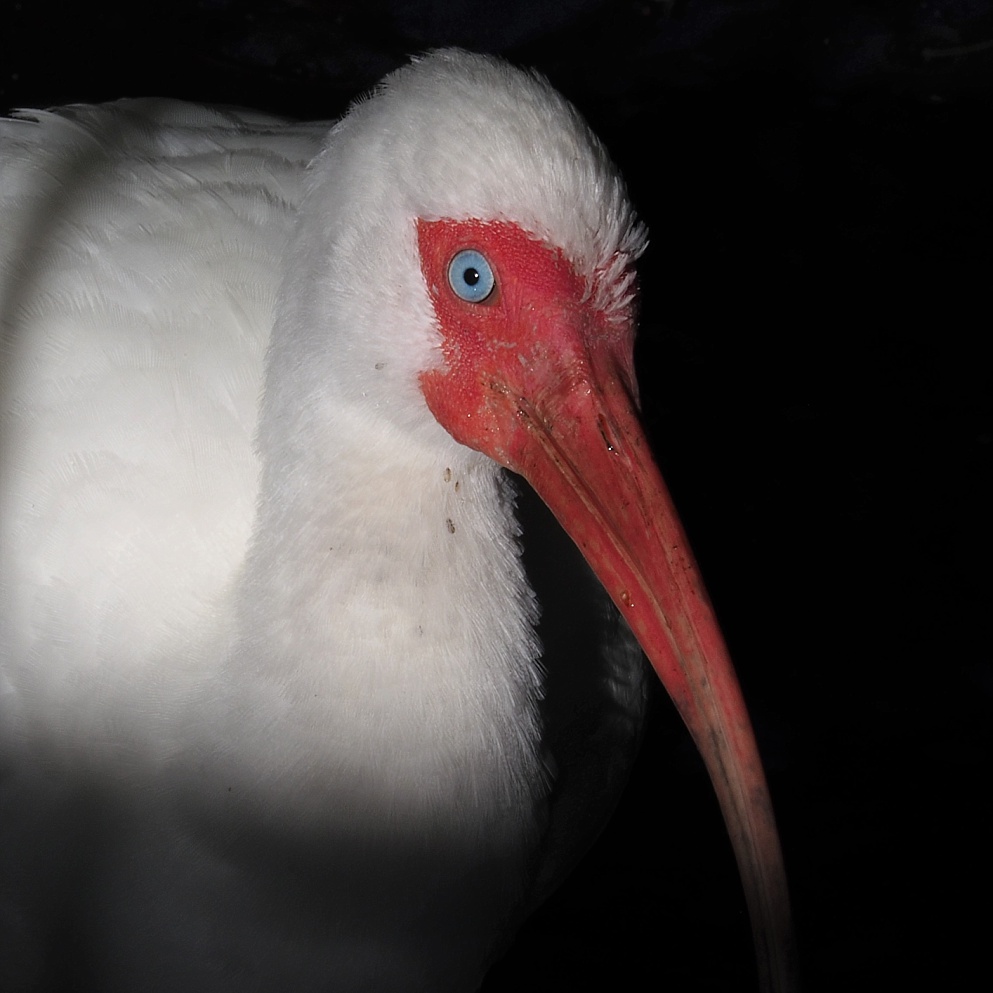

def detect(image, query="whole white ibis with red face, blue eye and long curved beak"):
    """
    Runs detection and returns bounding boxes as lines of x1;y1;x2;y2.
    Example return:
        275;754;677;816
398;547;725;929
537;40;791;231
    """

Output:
0;52;791;993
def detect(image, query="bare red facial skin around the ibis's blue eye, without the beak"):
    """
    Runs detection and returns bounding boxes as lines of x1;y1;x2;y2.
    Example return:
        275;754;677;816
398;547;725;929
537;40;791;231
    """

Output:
417;220;634;468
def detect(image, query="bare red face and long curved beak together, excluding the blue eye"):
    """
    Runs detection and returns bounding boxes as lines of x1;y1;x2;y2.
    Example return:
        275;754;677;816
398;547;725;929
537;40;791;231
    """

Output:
417;220;795;993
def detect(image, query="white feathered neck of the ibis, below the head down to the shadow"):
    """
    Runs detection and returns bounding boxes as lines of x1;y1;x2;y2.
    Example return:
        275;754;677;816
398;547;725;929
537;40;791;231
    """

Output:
226;415;544;829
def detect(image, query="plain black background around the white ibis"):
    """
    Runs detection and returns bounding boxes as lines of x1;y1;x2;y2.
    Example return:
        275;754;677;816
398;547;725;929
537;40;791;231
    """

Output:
0;0;993;993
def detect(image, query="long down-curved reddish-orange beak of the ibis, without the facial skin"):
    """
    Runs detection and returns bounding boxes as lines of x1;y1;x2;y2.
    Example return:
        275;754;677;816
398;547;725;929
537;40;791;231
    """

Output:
506;330;795;993
